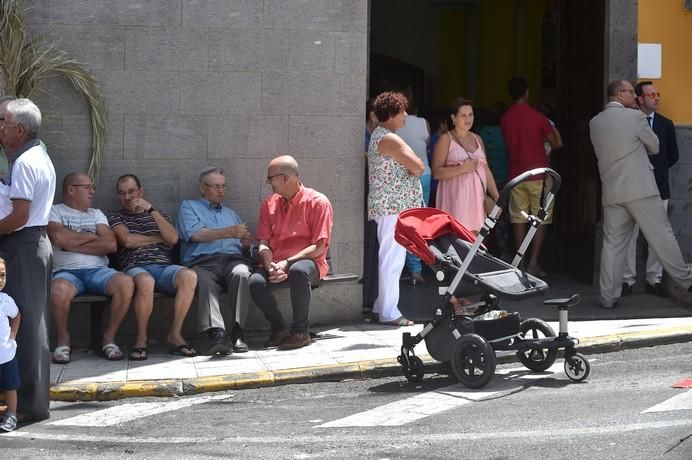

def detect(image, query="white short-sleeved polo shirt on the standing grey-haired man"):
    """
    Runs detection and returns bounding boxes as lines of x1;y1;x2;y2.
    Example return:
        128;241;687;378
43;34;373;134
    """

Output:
10;142;55;230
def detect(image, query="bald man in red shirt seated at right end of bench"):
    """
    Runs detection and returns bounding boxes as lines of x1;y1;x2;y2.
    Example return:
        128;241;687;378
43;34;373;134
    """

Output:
250;155;334;350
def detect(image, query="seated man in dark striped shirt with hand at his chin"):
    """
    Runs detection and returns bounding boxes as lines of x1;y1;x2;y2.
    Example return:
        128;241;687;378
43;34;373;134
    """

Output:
108;174;197;361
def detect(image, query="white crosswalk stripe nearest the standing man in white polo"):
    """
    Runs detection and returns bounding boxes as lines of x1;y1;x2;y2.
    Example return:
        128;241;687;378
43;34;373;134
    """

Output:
47;394;235;426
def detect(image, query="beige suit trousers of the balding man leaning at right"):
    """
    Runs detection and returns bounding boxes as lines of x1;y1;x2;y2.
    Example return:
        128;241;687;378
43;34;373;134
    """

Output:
600;196;692;306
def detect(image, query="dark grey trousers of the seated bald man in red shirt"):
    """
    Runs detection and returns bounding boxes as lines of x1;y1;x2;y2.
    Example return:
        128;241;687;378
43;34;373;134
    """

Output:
250;260;320;333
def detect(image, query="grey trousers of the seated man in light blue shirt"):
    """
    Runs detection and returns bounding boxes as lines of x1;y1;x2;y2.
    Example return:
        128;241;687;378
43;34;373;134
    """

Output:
190;254;250;333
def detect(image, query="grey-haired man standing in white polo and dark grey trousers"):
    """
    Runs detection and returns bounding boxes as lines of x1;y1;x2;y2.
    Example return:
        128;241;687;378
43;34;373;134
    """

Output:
0;99;55;421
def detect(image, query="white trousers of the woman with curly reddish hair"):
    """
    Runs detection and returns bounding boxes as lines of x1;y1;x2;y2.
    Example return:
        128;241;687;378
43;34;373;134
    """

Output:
372;214;406;322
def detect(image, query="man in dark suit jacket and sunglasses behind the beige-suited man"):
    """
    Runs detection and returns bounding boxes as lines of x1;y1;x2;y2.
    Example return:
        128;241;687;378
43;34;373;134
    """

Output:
622;81;680;297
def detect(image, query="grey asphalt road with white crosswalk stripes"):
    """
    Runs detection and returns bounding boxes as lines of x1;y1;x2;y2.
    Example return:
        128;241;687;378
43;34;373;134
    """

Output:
0;343;692;460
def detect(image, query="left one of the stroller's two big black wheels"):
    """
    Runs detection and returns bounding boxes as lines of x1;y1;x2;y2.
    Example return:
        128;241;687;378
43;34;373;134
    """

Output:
452;334;496;388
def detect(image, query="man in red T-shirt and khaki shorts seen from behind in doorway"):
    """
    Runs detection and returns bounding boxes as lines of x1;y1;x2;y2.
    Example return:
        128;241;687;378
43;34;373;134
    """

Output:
500;77;562;276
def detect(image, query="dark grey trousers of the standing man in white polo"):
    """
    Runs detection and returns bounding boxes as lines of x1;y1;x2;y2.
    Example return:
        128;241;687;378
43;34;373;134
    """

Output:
0;227;53;420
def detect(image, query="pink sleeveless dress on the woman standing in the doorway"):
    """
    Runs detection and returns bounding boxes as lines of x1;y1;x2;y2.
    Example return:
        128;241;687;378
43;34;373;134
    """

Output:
435;133;487;232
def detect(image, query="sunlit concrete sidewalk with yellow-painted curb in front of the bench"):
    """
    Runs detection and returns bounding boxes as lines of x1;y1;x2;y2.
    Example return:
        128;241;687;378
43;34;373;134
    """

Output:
51;276;692;401
